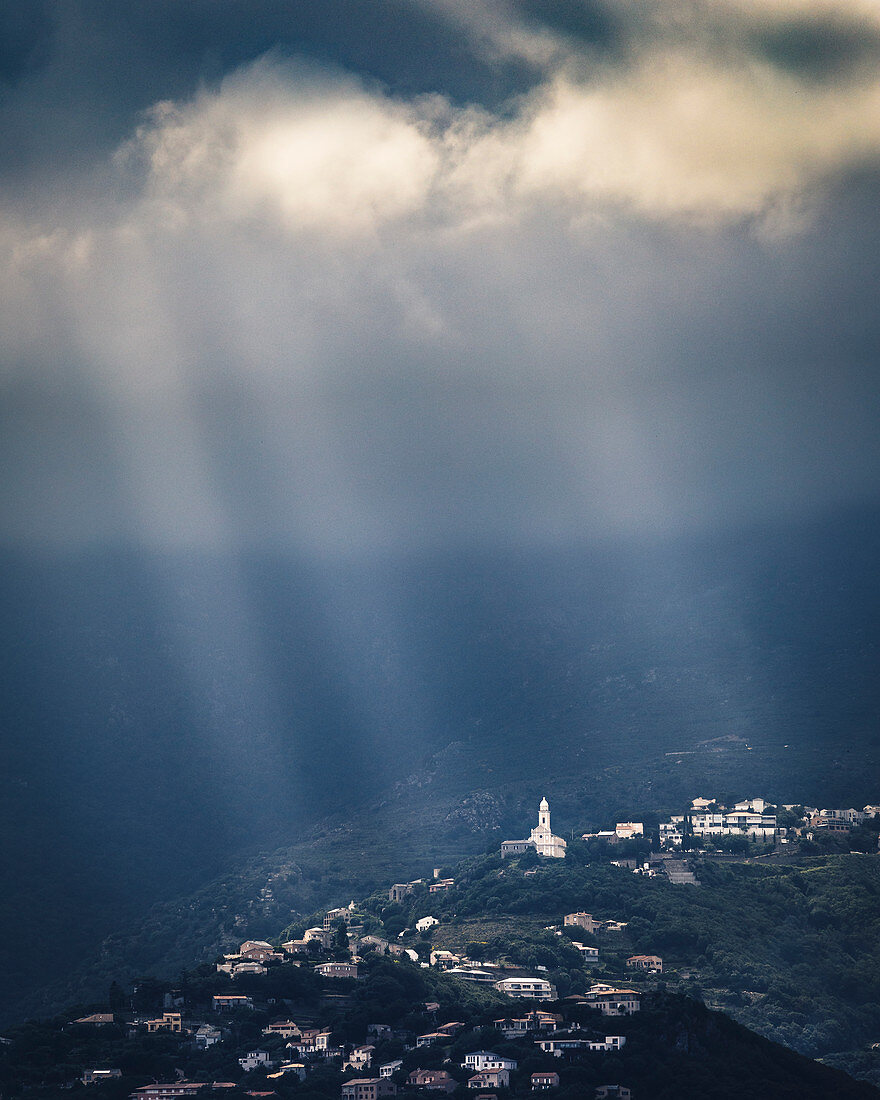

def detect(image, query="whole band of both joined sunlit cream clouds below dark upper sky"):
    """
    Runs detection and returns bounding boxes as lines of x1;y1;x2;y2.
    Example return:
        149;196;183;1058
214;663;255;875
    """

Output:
111;36;880;237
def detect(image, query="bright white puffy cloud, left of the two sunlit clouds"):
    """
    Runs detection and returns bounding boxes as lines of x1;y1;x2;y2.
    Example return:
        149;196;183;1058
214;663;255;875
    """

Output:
123;61;438;235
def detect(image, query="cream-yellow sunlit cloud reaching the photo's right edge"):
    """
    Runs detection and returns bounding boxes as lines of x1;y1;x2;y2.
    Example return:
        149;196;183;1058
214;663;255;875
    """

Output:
515;53;880;220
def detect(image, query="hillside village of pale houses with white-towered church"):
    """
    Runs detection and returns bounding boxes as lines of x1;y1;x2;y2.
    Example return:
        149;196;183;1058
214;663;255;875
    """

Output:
0;798;878;1100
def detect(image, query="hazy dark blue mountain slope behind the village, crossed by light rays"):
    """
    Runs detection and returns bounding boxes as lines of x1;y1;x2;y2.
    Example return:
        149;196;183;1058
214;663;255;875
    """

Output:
0;506;880;1020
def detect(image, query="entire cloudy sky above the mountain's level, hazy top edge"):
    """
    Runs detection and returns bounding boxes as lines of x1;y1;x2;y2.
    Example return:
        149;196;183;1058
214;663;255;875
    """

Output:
0;0;880;559
